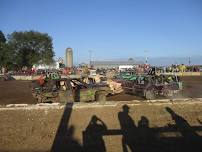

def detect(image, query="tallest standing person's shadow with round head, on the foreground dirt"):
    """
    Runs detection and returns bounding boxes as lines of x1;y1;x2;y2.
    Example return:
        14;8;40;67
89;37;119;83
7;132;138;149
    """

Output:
118;105;136;152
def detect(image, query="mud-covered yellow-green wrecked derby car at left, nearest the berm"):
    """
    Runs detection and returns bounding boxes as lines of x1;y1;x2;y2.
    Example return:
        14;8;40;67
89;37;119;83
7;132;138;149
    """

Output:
32;78;111;103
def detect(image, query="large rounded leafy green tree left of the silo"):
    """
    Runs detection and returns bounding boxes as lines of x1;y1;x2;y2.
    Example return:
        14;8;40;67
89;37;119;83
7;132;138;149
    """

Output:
8;31;54;67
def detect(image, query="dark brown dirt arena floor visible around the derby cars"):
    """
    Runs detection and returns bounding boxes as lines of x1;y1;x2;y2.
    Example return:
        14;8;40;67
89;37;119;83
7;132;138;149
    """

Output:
0;76;202;105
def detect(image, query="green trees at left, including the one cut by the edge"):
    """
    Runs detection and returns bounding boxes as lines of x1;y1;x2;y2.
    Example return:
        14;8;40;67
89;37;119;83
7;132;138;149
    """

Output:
0;31;54;70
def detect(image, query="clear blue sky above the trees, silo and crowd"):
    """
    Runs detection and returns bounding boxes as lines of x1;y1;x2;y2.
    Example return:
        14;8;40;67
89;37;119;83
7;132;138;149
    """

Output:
0;0;202;63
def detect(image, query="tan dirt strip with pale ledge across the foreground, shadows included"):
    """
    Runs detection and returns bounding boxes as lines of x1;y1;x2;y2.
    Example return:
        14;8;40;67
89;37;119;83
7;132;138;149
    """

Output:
0;100;202;152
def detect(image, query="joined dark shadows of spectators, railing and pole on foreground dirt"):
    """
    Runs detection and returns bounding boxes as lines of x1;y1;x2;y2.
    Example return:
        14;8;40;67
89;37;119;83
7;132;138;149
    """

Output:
52;105;202;152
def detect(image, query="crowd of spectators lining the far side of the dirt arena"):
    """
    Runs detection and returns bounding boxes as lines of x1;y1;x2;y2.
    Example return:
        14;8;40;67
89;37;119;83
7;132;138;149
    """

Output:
0;64;202;75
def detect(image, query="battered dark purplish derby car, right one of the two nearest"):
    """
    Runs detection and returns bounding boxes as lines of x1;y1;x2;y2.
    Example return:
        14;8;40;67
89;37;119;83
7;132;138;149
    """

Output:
122;75;182;100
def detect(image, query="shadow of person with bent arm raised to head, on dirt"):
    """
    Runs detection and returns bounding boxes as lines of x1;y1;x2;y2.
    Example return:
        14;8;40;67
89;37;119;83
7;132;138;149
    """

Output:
84;115;107;152
